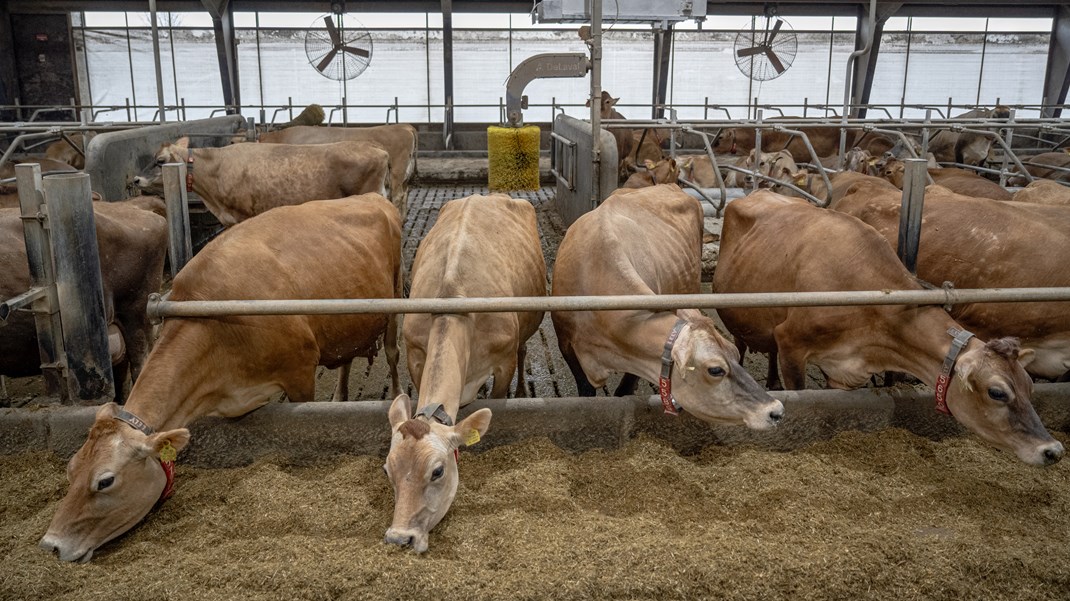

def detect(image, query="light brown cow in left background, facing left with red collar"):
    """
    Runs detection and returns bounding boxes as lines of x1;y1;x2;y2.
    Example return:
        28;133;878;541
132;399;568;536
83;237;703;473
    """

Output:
134;138;391;226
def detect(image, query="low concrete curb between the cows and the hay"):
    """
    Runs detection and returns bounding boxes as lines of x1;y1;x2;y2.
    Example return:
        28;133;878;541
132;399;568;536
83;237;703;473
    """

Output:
0;384;1070;467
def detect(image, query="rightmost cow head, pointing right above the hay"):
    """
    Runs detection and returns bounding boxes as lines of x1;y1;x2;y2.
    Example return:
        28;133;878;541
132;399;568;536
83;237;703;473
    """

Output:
947;338;1064;465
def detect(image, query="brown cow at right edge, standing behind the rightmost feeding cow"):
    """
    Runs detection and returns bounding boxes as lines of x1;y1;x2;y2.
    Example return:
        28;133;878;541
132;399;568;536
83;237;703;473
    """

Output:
834;186;1070;380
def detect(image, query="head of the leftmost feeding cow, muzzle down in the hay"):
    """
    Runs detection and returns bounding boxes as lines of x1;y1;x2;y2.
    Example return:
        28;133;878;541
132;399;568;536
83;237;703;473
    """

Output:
41;403;189;563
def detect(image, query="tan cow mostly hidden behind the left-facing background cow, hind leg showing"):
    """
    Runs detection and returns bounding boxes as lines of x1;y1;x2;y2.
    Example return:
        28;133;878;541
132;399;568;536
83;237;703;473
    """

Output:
259;123;419;224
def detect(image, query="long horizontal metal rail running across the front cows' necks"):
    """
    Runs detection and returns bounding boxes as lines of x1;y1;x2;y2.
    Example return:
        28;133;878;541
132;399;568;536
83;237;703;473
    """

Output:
148;288;1070;319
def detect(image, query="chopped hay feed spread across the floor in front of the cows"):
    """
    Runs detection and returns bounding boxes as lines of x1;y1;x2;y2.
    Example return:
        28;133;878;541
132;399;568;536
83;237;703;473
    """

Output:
0;430;1070;601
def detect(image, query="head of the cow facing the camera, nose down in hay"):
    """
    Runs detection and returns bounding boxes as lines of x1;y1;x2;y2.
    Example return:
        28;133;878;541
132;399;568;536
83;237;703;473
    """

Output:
383;395;490;553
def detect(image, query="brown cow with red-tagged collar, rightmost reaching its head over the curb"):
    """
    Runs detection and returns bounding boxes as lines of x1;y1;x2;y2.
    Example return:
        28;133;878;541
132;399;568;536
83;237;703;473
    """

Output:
714;191;1063;465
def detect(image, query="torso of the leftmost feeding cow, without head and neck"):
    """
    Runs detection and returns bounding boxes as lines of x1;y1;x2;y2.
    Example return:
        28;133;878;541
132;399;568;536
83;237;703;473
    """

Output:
169;194;401;368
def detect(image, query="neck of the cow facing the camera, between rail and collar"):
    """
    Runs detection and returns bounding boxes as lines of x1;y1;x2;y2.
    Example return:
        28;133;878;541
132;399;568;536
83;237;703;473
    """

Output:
416;314;475;419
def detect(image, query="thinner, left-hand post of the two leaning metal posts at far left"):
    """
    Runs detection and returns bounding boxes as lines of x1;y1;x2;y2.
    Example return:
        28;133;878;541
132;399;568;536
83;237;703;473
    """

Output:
15;163;68;402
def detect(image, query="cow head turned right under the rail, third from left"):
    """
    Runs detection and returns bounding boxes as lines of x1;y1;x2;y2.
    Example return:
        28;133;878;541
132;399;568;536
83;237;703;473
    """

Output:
672;309;784;430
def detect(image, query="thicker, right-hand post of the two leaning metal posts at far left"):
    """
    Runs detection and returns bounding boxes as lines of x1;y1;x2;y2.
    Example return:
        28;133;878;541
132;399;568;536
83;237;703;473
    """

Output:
43;173;116;401
